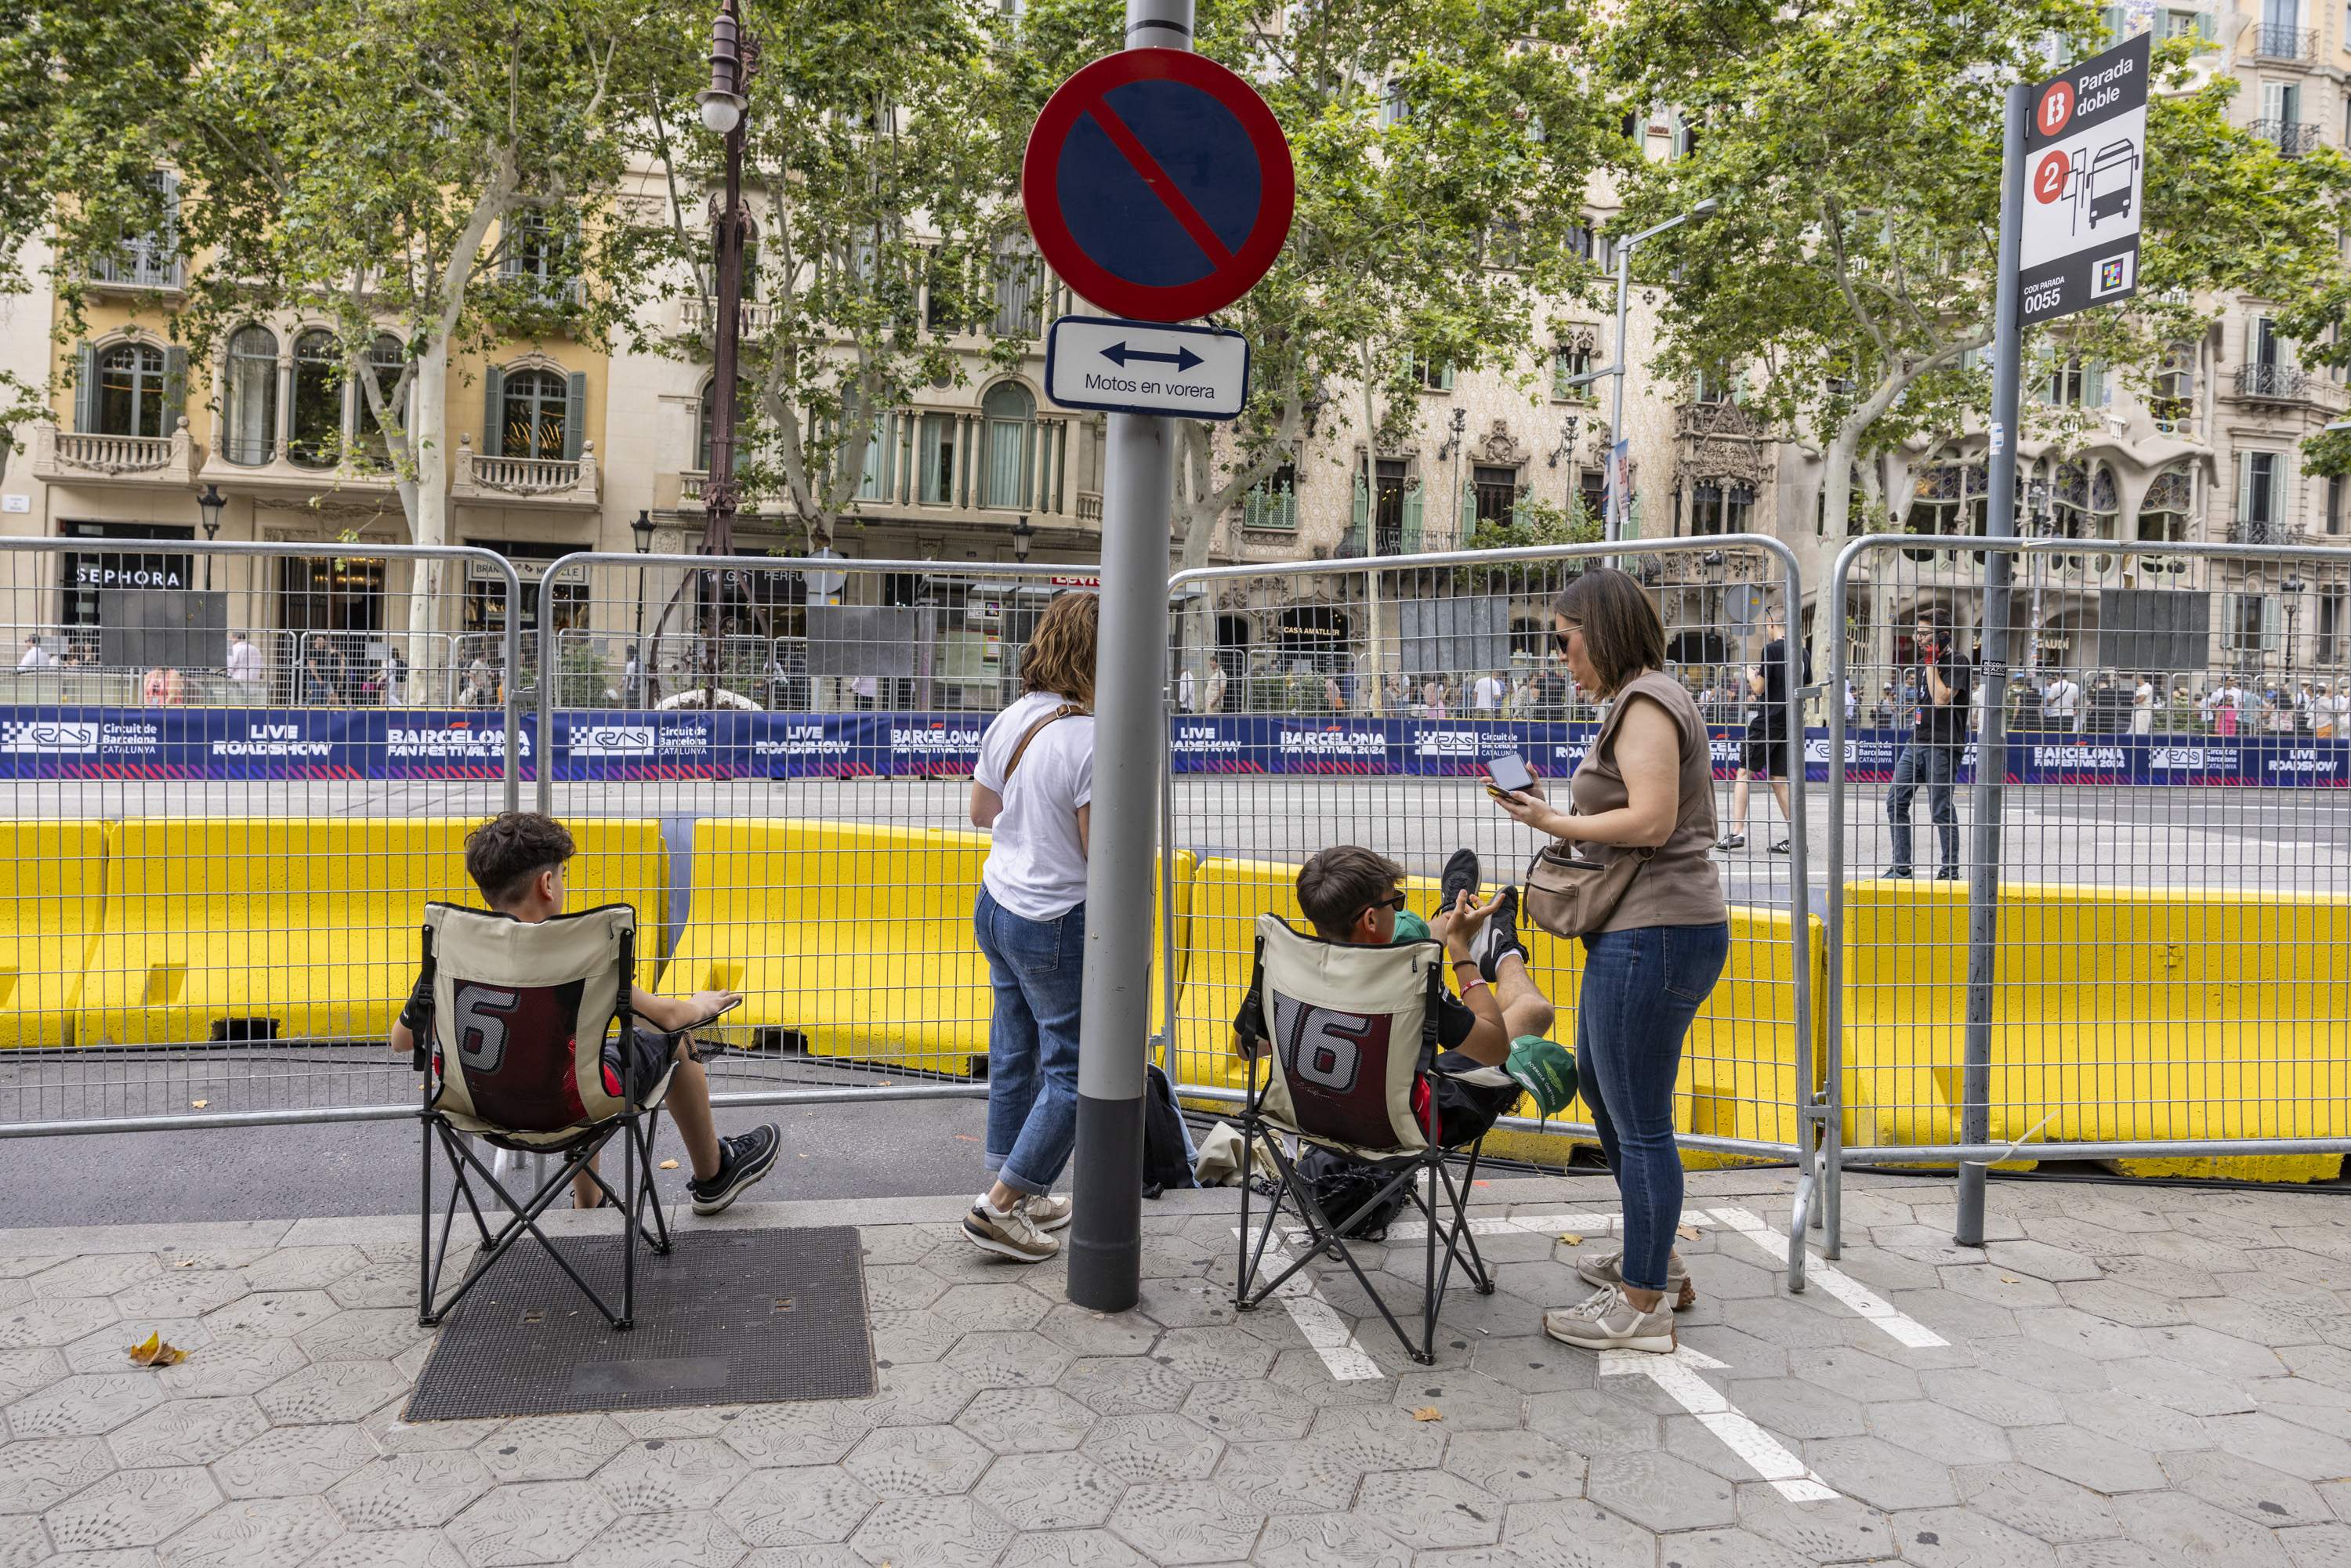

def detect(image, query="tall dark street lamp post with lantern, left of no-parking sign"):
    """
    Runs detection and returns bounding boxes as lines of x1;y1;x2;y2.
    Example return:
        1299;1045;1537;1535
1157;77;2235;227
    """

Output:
696;0;759;712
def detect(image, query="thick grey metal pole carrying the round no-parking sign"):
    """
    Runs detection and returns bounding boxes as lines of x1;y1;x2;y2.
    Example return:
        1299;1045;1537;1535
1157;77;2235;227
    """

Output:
1070;0;1192;1312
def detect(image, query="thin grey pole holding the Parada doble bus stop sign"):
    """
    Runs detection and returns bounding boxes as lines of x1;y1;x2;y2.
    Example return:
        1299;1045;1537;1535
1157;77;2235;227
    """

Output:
1951;82;2034;1246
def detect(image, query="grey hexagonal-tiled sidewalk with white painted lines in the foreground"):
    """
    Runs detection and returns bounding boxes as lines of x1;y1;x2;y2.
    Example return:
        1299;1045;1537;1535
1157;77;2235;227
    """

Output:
0;1171;2351;1568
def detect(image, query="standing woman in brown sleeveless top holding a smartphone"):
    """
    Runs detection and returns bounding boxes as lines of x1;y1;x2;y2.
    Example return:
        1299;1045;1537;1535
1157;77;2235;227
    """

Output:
1495;567;1730;1352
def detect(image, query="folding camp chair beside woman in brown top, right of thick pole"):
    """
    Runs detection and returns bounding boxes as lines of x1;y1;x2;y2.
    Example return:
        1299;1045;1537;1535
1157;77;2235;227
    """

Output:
1234;914;1509;1366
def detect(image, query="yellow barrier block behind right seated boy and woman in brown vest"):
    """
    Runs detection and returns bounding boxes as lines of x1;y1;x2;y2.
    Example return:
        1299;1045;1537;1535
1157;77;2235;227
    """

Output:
1176;858;1824;1164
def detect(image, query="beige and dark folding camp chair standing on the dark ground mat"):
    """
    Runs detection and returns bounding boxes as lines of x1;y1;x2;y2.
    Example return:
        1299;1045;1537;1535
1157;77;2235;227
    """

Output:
414;903;675;1328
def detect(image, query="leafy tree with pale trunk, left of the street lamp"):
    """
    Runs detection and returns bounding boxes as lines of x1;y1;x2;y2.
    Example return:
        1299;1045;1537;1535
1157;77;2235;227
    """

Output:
174;0;708;665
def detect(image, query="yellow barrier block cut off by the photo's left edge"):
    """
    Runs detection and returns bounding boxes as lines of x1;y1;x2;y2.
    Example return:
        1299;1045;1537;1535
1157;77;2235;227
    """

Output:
0;820;106;1048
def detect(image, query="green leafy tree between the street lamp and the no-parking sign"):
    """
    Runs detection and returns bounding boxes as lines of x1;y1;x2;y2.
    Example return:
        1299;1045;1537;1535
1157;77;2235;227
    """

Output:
647;0;1034;557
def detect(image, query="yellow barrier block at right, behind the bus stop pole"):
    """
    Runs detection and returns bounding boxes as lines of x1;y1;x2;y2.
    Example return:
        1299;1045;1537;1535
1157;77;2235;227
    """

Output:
1843;882;2351;1171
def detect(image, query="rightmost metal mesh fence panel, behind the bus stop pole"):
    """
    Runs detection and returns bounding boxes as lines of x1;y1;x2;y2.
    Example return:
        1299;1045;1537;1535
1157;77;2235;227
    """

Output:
1822;541;2351;1241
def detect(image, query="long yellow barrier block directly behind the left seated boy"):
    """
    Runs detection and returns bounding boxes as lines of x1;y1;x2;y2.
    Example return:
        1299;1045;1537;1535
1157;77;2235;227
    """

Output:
75;818;668;1044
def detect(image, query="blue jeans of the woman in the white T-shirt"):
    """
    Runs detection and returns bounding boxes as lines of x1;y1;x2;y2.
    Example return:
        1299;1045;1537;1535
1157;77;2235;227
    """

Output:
971;889;1086;1194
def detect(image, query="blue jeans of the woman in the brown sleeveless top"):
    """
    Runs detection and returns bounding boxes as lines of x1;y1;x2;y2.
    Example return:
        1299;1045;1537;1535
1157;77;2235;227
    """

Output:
1575;924;1730;1291
